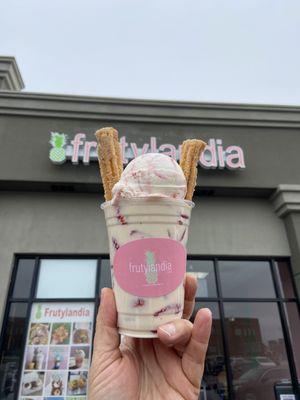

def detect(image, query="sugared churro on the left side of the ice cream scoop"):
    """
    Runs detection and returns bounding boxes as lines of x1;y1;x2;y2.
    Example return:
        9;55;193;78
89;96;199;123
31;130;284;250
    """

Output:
95;127;123;201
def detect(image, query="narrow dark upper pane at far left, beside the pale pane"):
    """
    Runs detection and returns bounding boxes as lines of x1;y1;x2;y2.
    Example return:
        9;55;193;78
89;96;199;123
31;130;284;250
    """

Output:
13;258;35;299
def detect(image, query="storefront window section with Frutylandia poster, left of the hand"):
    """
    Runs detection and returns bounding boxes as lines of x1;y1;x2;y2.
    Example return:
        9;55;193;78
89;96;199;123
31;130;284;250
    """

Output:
0;257;101;400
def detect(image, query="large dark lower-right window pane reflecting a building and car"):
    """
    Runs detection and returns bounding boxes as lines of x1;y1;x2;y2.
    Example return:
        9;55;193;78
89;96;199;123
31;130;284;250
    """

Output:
224;303;291;400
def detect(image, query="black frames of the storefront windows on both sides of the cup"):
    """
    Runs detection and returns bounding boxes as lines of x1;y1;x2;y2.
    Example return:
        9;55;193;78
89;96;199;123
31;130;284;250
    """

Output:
0;253;300;400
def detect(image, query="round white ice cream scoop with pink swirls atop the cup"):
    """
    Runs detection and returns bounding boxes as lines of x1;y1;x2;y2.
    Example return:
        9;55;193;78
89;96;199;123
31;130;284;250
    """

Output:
112;153;187;203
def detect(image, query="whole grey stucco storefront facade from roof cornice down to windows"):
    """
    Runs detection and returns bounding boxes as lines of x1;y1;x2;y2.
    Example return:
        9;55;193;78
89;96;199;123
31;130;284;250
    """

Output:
0;91;300;332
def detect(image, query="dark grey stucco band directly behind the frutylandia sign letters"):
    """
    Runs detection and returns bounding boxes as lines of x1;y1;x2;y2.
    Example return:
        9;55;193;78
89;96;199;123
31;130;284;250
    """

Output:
0;116;300;189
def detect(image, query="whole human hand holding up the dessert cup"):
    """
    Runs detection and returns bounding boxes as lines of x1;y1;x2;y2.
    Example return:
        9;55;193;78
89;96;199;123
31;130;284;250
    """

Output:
89;275;212;400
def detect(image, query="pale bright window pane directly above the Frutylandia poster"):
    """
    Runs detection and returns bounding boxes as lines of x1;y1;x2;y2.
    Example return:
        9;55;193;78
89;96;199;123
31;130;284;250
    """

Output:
36;259;97;299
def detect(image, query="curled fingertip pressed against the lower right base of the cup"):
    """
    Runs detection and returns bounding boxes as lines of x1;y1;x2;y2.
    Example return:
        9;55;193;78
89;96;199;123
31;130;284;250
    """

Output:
157;319;193;348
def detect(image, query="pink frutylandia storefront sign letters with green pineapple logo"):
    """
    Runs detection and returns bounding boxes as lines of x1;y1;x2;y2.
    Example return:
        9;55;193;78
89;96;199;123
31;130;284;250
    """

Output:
49;132;246;170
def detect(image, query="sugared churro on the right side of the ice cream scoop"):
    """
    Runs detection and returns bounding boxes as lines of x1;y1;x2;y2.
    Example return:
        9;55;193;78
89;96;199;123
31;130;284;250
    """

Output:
180;139;206;200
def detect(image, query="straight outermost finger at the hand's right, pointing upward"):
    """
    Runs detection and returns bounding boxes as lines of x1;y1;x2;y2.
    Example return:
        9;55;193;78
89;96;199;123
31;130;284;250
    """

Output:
182;308;212;387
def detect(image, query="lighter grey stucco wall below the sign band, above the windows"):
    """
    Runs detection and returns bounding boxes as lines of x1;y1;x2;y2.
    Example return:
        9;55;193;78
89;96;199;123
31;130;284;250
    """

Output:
0;192;290;326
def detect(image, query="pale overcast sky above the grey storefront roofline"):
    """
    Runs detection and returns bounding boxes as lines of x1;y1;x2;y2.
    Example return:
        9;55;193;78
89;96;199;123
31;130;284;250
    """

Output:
0;0;300;105
